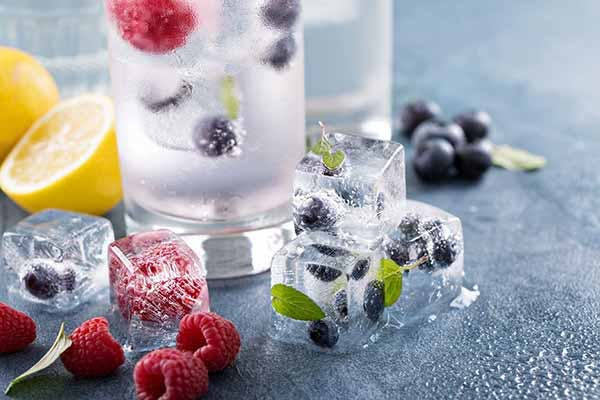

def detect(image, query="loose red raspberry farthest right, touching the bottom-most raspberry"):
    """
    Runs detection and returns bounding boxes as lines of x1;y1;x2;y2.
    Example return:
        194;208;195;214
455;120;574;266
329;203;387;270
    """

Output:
177;313;240;372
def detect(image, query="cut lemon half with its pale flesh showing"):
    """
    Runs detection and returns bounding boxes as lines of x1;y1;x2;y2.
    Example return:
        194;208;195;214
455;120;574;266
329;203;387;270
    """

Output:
0;95;122;215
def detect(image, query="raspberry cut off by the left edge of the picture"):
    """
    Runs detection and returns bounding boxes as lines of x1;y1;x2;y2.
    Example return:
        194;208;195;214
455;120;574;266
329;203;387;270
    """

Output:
0;303;36;353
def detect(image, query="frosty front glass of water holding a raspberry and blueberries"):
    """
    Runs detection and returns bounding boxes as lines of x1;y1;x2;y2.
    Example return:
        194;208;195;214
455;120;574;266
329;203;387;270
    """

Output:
99;0;305;278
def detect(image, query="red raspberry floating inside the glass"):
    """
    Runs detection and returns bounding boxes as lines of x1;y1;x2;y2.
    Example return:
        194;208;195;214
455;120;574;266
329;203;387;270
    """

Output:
108;0;197;54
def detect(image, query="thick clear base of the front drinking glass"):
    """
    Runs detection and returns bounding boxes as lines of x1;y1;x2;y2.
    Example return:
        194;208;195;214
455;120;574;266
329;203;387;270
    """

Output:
125;204;295;279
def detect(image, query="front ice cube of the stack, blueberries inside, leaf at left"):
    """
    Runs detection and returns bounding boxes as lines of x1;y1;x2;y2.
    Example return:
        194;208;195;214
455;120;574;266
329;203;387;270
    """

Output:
271;232;386;351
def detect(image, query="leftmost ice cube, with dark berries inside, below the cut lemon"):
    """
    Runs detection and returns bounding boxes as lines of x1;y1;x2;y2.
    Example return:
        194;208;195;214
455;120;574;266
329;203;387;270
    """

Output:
2;210;114;312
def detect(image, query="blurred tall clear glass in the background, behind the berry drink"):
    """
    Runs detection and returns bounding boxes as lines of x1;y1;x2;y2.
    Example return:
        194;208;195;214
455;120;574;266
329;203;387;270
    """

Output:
302;0;393;140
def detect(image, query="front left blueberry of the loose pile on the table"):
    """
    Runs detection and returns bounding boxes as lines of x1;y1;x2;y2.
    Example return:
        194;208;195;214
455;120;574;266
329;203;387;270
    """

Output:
413;139;455;181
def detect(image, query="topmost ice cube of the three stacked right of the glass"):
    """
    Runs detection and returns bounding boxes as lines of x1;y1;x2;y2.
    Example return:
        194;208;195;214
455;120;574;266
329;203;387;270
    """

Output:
293;133;406;242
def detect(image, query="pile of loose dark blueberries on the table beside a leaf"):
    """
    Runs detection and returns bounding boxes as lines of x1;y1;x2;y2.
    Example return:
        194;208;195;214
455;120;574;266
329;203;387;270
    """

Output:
400;101;493;181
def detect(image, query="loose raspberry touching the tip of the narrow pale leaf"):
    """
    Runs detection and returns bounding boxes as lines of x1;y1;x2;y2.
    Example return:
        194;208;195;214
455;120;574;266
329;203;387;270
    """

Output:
60;318;125;377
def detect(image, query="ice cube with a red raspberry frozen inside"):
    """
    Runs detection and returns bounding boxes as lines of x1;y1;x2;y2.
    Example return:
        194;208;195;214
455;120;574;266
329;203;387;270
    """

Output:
109;230;209;352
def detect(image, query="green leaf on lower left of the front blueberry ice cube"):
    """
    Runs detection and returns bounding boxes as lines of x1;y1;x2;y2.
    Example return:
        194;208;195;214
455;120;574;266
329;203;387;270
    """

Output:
271;283;325;321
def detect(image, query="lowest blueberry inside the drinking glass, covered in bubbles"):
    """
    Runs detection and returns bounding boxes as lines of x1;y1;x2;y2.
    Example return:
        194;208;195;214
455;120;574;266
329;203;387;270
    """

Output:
193;116;241;157
